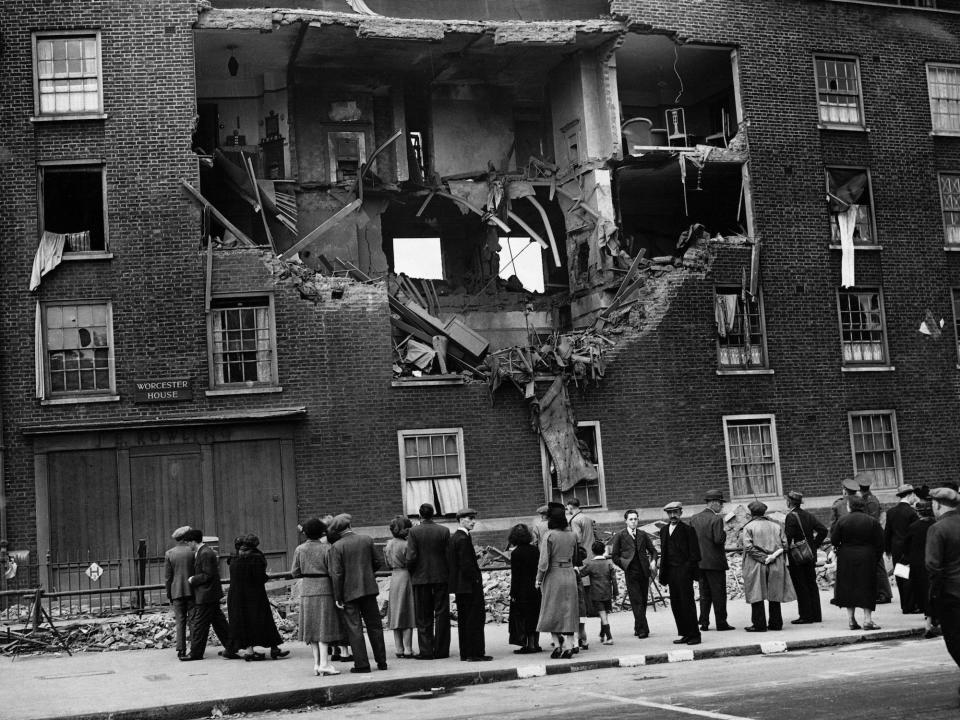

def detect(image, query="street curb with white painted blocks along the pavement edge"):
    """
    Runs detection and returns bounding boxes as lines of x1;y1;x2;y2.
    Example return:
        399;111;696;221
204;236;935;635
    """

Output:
35;628;923;720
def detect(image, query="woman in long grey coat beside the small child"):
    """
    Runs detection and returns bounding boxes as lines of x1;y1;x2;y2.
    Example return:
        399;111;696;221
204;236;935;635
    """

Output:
536;507;580;659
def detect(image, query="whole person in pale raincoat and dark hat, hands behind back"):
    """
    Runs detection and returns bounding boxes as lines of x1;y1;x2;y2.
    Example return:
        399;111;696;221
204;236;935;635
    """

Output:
740;500;797;632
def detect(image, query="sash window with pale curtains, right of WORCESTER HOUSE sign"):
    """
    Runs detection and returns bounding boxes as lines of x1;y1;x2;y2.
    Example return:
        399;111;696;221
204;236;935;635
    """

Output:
210;296;277;387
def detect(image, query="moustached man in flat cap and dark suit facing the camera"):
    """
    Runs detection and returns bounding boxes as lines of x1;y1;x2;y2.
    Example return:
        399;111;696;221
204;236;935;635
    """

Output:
660;501;701;645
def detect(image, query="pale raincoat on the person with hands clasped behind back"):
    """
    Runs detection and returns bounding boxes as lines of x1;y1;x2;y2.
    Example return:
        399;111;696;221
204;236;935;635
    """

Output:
740;517;797;603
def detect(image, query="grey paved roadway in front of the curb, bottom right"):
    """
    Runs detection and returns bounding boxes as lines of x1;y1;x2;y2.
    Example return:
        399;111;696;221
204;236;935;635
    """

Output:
244;639;960;720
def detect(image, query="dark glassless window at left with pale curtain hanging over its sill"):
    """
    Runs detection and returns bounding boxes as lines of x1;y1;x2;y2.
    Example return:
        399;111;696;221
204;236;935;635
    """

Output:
40;162;108;252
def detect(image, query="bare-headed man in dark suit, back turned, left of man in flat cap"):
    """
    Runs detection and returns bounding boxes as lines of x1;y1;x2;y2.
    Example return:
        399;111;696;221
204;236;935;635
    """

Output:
407;503;450;660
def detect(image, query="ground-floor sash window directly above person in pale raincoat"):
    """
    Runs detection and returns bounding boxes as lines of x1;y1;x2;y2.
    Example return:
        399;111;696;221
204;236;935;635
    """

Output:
723;415;781;499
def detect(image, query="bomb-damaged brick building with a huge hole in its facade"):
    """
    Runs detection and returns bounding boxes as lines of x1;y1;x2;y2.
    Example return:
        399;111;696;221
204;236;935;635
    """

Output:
0;0;960;584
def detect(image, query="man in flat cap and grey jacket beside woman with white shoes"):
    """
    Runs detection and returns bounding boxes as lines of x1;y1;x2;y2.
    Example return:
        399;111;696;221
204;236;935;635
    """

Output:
327;514;387;673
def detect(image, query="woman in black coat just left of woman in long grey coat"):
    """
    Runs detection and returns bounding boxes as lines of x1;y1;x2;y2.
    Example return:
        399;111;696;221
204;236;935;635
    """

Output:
507;523;540;655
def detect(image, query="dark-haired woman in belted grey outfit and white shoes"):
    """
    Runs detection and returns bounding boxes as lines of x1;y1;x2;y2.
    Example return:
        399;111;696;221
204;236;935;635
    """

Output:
290;518;342;675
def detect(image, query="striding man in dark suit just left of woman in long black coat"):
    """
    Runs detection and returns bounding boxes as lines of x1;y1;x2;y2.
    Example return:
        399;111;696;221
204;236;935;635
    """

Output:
180;529;240;661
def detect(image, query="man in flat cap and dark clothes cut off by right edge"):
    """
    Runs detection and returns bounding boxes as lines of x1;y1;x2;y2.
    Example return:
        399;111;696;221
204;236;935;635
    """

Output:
926;487;960;692
